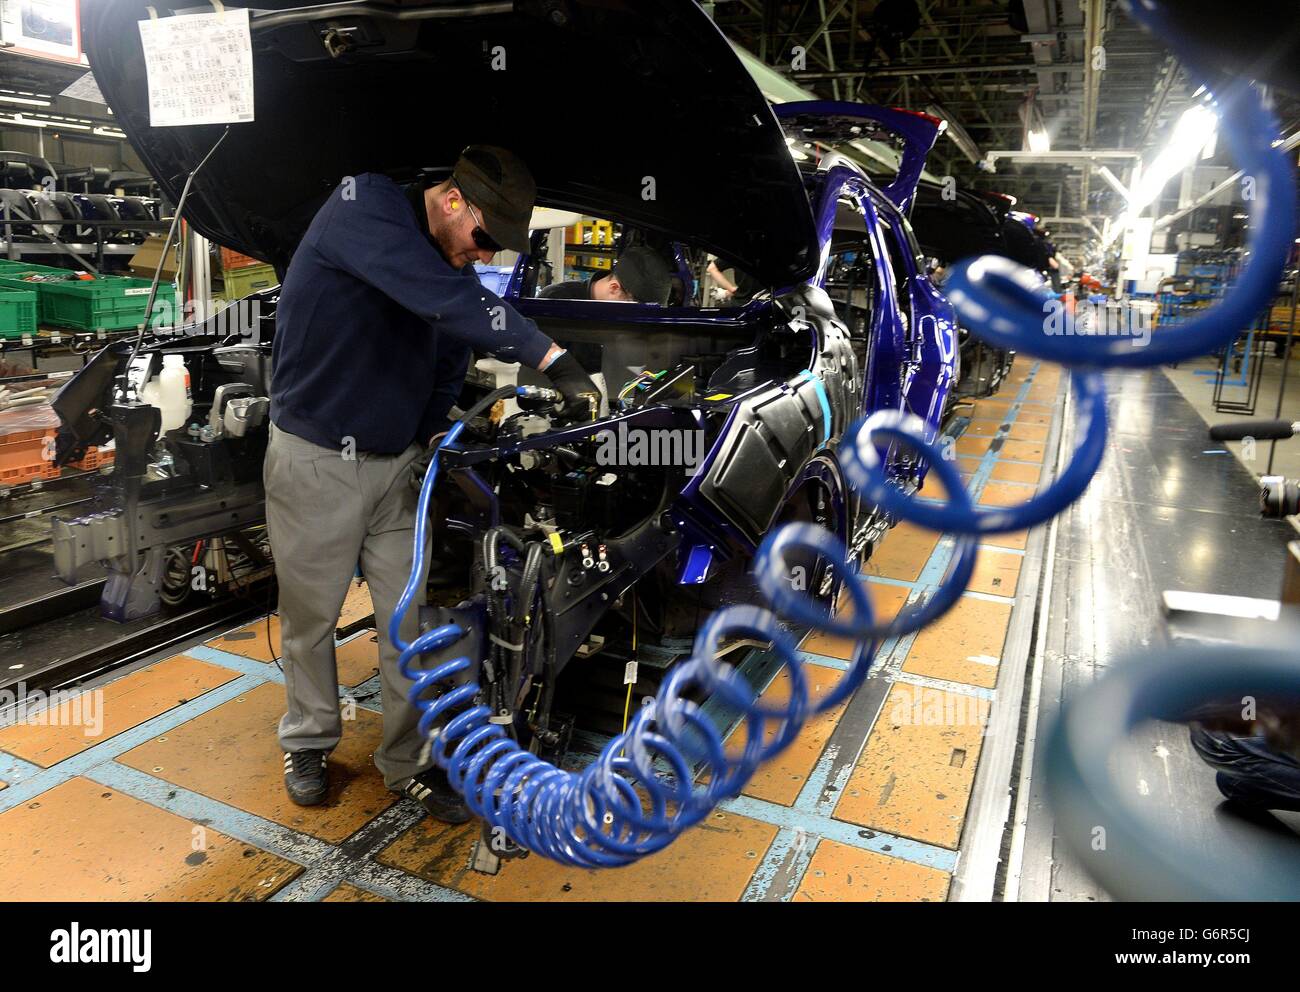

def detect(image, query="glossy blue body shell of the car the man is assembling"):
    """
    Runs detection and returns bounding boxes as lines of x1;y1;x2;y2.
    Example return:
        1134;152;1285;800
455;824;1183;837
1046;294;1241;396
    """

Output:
450;103;957;621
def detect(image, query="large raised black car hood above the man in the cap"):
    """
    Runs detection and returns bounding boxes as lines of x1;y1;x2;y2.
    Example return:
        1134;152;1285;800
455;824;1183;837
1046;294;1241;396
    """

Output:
82;0;816;286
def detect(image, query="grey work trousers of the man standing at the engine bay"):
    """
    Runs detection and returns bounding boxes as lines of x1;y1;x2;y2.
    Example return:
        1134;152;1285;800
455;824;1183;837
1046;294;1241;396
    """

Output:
263;424;432;789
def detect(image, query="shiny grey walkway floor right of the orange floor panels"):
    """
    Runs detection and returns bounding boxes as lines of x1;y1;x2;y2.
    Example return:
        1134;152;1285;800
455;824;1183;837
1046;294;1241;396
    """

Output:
1014;369;1300;901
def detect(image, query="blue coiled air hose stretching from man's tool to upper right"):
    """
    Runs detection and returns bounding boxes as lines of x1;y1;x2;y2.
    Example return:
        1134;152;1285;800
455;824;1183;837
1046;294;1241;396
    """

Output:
389;4;1296;867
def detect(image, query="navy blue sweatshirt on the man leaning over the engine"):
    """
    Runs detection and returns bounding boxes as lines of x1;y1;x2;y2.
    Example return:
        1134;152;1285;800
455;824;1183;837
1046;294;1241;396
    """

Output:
270;173;551;454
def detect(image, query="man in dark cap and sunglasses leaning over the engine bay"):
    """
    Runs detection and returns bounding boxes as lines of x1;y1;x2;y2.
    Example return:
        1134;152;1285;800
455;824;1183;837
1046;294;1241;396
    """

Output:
264;146;598;823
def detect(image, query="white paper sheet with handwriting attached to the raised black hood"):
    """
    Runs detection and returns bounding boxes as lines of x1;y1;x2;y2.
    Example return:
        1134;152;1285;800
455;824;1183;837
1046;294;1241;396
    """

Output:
139;8;252;127
